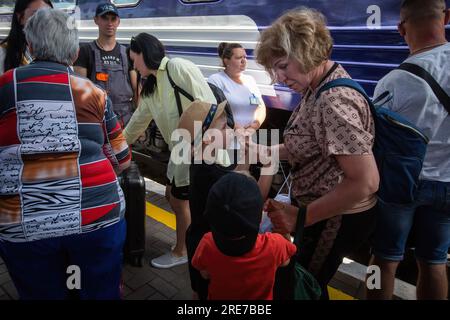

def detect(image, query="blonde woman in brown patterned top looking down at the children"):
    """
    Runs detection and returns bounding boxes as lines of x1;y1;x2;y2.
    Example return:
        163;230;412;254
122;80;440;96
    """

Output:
256;8;379;298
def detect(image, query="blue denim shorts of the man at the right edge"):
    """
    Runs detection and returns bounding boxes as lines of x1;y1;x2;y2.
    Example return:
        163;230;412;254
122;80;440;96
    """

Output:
373;180;450;264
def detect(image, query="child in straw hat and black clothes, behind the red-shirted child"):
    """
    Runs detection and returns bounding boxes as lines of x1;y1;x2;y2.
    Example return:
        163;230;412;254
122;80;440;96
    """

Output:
174;101;262;300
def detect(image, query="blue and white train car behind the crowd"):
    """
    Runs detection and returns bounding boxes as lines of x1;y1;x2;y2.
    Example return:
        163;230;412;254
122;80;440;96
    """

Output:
0;0;450;168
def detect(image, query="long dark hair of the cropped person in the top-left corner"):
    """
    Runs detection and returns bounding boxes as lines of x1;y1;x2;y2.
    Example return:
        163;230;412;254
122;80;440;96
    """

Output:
2;0;53;71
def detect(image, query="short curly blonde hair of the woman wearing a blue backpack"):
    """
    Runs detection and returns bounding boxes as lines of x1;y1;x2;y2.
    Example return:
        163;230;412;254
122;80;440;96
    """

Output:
256;7;333;80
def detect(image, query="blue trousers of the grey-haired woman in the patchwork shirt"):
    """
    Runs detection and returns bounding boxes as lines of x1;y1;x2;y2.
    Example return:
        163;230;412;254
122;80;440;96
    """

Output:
0;219;126;300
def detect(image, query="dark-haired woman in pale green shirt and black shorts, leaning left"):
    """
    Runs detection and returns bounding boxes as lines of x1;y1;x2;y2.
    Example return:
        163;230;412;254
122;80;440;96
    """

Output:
124;33;217;268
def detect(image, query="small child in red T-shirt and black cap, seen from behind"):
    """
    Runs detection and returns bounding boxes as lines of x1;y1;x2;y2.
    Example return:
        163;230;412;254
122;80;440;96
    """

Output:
192;173;297;300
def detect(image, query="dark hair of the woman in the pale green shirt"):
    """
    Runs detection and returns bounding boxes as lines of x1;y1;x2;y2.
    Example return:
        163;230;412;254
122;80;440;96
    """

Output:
130;32;166;97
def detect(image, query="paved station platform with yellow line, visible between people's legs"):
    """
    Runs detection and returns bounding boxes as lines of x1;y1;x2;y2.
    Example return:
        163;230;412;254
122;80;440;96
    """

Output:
0;178;416;300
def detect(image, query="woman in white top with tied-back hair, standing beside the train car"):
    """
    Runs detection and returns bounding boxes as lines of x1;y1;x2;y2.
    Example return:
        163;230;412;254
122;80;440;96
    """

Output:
208;42;266;129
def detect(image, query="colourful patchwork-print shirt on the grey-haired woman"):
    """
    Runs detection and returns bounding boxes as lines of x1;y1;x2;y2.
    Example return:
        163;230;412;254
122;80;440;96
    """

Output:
0;61;130;242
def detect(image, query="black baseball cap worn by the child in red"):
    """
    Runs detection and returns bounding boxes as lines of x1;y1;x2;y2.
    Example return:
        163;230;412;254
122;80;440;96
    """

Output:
205;173;264;256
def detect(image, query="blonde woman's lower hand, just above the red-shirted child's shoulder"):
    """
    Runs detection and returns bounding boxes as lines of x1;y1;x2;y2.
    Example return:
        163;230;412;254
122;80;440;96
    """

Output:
264;199;298;234
